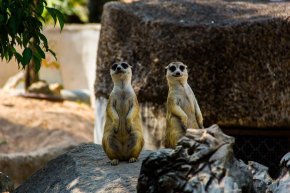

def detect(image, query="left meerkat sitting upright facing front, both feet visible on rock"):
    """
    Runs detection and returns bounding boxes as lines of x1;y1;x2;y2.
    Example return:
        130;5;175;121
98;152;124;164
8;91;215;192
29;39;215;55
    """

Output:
102;62;144;165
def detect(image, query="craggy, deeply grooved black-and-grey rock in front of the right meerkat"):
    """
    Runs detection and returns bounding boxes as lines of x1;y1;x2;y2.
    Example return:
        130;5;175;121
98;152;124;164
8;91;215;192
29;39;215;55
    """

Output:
137;125;253;193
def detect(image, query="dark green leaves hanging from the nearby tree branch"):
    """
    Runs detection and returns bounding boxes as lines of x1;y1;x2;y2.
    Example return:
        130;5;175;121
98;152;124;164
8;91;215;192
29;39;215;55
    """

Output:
0;0;64;71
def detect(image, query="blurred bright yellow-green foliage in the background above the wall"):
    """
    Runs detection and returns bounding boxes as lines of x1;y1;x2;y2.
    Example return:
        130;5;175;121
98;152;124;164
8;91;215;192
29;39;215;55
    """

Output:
43;0;88;23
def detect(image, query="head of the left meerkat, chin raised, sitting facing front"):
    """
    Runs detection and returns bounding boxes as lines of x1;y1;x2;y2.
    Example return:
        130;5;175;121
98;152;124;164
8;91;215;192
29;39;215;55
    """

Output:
110;62;132;82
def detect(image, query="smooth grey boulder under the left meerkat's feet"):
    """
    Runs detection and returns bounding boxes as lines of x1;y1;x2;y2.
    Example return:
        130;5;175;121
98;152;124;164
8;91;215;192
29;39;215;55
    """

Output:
14;144;150;193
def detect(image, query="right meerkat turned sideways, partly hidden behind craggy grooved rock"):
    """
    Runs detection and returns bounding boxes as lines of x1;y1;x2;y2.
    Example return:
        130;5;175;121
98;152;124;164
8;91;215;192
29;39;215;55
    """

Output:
165;62;203;148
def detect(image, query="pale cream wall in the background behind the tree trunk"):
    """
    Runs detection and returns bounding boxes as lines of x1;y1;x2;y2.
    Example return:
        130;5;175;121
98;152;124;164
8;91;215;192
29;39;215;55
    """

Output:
0;24;101;106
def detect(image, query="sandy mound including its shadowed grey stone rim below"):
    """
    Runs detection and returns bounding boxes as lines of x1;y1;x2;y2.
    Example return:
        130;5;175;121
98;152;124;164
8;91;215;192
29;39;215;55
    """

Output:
0;90;94;186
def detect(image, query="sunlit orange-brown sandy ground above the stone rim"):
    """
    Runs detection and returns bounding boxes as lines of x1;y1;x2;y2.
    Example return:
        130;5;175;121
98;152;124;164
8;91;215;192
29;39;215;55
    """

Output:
0;90;94;153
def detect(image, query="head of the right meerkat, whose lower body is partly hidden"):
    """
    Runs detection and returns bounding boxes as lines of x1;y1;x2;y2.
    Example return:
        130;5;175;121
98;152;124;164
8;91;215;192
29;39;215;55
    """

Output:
165;62;188;83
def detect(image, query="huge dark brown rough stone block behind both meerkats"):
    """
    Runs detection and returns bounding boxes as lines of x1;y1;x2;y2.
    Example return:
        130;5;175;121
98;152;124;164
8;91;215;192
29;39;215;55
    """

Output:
95;0;290;128
